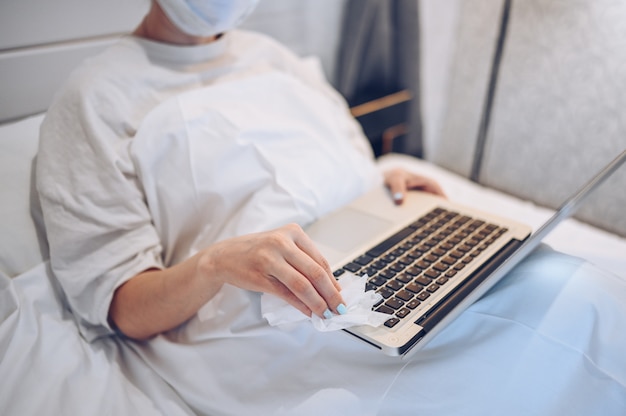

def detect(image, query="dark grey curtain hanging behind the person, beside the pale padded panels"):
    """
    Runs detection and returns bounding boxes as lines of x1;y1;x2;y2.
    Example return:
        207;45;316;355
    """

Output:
336;0;422;157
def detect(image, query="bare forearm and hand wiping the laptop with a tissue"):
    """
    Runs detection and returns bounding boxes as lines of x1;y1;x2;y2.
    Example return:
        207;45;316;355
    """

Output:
109;224;345;339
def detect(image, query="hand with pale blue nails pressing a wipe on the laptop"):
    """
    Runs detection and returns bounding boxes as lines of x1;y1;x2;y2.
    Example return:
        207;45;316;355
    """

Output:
200;224;345;317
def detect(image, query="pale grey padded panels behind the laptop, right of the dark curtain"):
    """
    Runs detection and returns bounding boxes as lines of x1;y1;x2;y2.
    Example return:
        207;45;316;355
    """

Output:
431;0;626;236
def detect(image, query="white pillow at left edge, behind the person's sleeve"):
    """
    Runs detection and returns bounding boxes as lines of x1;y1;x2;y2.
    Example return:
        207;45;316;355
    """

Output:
0;114;47;277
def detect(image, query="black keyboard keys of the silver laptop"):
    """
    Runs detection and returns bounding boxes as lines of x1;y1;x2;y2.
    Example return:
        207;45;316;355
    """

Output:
334;208;507;328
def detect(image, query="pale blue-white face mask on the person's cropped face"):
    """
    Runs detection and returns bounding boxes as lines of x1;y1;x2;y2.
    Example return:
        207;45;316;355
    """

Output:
157;0;258;37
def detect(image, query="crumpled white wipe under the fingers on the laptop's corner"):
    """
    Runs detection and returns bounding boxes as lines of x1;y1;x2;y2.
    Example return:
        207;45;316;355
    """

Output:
261;273;389;332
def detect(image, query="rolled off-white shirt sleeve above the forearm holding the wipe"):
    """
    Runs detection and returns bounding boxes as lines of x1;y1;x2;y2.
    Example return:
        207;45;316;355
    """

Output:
36;70;163;341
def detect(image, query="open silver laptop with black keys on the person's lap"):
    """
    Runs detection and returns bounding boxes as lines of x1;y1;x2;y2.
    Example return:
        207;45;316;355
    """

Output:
305;150;626;357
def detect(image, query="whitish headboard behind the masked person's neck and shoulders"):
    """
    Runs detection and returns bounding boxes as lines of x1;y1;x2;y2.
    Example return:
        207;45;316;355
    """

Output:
0;0;344;123
